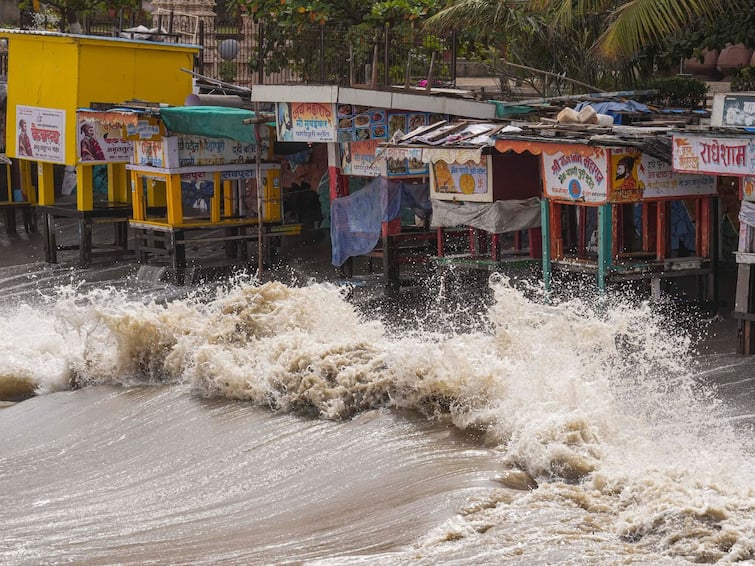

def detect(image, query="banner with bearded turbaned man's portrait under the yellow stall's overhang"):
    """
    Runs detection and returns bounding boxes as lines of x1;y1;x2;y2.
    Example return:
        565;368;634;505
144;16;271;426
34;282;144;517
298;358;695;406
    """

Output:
76;112;134;163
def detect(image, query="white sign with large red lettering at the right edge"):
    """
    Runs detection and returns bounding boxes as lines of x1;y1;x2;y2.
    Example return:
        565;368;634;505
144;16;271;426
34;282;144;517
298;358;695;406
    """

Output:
672;134;755;176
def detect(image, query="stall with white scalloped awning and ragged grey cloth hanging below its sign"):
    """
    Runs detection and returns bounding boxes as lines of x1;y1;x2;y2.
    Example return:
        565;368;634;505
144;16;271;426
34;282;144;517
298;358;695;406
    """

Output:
386;120;541;276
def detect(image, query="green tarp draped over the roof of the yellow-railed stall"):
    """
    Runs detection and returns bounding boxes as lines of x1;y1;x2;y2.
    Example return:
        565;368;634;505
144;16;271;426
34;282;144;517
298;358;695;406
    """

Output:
160;106;256;143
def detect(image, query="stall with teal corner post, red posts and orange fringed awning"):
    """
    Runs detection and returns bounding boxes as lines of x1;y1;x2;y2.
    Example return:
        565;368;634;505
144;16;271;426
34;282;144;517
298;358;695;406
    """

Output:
496;126;716;299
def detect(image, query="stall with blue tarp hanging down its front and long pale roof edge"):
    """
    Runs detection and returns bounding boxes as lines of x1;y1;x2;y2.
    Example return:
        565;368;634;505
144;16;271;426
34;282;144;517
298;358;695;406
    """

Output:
252;85;496;286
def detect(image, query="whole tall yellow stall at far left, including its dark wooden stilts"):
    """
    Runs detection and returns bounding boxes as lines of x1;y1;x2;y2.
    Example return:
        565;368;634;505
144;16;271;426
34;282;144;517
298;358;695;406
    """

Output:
0;30;200;265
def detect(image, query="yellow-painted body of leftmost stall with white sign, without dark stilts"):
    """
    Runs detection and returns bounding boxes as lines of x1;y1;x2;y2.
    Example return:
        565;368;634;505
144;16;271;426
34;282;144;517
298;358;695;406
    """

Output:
0;30;200;210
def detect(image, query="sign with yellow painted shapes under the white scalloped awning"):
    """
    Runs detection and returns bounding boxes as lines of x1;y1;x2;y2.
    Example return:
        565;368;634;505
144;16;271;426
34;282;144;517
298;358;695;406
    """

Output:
431;160;493;201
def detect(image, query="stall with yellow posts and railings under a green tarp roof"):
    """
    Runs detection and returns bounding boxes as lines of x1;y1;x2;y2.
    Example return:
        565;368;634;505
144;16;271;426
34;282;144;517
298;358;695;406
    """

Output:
126;106;286;271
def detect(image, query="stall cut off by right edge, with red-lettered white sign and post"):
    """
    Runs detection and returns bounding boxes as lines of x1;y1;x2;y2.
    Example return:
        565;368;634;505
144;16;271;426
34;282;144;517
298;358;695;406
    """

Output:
673;93;755;355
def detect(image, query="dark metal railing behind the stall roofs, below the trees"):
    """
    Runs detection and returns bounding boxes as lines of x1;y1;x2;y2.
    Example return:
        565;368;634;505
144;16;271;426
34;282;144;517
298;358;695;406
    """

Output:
10;13;456;91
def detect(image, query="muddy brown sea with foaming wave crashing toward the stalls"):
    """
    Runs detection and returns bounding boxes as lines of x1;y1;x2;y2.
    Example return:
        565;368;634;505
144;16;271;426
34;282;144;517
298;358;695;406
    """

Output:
0;266;755;565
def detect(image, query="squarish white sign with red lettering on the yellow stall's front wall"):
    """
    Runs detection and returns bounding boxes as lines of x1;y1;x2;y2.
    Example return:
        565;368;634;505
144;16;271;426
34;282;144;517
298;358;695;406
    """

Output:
16;105;66;163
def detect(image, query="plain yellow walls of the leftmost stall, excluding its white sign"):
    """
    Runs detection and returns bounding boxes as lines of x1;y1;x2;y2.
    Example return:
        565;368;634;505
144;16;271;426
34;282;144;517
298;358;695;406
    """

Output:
0;30;199;165
